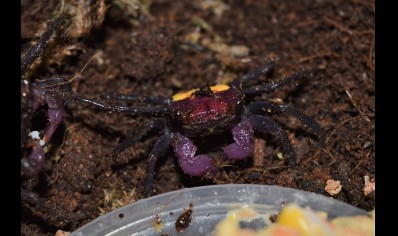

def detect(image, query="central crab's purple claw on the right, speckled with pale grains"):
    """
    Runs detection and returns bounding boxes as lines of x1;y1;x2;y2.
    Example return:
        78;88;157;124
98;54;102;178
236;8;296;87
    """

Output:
224;117;254;160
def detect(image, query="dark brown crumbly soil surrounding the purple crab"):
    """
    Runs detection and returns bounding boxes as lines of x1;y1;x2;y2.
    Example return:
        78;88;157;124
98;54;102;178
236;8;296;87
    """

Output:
21;0;375;235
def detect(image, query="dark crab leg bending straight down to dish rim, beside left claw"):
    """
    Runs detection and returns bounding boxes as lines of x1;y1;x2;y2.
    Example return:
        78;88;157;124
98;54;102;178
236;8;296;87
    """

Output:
144;134;171;197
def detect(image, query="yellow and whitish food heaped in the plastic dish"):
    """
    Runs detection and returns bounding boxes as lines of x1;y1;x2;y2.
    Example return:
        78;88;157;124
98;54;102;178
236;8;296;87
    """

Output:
215;204;375;236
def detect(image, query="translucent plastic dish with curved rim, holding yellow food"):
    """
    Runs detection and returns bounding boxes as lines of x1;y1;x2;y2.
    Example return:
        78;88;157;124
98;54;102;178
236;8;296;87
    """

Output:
71;184;367;236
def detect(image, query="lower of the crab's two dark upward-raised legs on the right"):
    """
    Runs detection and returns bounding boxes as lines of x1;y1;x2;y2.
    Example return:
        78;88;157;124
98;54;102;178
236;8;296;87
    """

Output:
243;70;311;95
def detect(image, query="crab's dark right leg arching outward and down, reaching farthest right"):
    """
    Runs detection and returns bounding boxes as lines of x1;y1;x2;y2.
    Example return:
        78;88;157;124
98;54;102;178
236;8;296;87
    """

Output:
249;101;324;146
